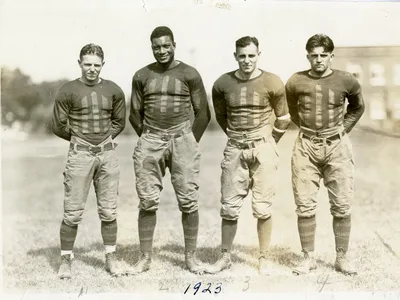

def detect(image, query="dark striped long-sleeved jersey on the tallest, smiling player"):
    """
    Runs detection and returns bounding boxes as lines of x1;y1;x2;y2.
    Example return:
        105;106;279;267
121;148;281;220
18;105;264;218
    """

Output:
129;62;211;141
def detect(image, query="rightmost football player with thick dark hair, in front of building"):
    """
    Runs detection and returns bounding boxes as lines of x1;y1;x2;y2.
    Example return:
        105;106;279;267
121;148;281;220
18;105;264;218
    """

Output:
286;34;364;274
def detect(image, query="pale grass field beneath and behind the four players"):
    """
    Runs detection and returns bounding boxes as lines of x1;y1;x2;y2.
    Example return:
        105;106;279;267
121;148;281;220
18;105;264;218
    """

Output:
2;128;400;295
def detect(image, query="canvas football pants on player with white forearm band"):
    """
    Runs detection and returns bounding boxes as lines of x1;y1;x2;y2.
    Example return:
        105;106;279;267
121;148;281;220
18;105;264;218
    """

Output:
220;126;279;220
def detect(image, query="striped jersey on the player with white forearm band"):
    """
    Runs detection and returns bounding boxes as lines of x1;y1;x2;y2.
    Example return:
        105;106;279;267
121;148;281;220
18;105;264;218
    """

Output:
212;70;289;131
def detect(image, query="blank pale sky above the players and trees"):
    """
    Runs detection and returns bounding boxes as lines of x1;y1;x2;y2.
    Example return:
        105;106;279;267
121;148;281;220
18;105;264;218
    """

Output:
0;0;400;93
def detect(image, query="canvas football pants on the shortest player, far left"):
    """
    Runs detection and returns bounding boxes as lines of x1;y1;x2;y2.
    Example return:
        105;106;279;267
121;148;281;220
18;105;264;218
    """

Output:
63;136;119;225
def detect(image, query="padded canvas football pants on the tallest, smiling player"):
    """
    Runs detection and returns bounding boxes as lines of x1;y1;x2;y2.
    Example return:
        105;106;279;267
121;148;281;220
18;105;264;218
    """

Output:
133;121;200;213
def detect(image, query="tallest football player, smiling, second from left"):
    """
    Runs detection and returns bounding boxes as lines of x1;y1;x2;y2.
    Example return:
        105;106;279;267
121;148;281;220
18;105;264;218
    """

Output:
129;26;210;274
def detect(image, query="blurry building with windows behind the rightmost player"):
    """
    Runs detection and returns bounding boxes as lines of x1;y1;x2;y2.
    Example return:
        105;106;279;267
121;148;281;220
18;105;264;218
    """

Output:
332;46;400;135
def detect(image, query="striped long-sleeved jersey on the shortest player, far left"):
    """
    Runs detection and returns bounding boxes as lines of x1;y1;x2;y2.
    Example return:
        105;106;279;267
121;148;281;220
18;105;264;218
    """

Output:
52;79;126;145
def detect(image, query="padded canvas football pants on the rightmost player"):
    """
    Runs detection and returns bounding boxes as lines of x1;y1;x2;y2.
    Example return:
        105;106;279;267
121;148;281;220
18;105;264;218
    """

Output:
292;126;354;218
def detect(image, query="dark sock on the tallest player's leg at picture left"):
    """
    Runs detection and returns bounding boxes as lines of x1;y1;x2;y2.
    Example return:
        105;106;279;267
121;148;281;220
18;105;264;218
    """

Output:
138;210;157;253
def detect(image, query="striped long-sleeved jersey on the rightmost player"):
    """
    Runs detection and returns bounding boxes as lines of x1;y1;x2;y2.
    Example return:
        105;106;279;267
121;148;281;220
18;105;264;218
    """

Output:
286;70;365;132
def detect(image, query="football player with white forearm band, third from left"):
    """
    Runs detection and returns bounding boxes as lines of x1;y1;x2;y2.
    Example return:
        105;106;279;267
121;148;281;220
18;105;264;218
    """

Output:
207;36;290;274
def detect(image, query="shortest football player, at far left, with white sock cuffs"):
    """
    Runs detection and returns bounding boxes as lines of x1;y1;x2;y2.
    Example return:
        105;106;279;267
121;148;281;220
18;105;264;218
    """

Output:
53;44;126;278
